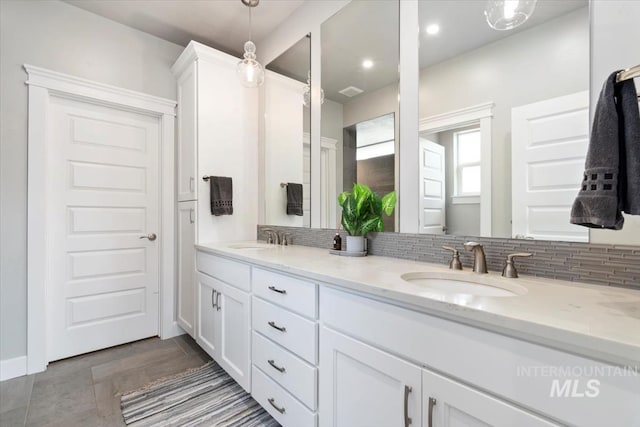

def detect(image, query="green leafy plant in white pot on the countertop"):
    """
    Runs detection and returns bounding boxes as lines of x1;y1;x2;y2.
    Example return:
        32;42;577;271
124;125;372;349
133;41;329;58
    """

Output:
338;183;396;252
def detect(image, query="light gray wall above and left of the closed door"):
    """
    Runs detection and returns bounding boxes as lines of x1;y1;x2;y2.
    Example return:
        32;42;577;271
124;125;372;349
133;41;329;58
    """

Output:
0;0;183;360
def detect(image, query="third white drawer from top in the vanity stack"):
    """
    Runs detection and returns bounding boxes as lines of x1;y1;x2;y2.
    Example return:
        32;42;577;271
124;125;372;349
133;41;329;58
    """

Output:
251;332;317;411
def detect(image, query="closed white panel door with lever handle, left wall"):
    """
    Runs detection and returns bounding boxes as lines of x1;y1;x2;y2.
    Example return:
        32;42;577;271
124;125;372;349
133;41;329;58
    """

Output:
47;97;162;360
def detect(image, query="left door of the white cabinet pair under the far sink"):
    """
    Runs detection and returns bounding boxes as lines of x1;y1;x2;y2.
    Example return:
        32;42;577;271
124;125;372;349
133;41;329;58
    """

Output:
196;273;220;360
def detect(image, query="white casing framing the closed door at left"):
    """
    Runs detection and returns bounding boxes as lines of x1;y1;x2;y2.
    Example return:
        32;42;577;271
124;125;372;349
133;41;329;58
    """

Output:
24;64;182;374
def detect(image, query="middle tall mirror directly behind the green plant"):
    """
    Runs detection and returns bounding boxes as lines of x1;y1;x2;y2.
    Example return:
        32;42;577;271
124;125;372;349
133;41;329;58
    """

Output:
320;0;400;231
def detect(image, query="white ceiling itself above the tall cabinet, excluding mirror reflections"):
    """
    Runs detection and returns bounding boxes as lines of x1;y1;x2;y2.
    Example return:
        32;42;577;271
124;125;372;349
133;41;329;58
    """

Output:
66;0;305;56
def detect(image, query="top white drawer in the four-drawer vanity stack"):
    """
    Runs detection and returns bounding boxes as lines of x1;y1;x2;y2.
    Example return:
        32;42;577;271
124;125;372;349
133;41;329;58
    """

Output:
252;267;318;319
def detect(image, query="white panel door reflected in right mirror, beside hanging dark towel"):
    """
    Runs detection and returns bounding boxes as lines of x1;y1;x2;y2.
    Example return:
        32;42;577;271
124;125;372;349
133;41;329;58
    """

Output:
511;92;589;242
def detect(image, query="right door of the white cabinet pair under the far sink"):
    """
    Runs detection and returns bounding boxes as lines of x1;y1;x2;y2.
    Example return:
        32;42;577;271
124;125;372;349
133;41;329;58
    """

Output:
216;281;251;391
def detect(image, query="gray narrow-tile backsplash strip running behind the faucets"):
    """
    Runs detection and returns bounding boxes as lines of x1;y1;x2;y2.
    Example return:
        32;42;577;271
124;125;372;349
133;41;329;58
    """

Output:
258;225;640;290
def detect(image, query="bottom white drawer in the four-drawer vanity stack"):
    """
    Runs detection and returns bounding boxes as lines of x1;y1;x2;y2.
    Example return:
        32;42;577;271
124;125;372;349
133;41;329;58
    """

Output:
251;366;316;427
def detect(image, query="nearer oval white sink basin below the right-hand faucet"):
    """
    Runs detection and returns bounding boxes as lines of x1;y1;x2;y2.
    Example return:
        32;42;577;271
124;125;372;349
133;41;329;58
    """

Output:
400;272;527;297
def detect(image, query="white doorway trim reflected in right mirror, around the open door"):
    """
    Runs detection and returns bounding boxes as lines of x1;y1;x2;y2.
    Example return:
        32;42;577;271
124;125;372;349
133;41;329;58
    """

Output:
418;102;494;237
